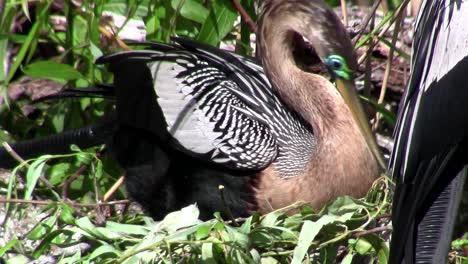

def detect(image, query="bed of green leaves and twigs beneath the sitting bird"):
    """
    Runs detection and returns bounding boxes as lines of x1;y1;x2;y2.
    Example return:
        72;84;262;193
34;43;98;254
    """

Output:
0;150;390;263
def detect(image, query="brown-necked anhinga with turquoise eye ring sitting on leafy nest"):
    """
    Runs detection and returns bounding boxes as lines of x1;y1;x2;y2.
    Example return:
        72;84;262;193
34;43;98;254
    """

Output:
0;0;383;218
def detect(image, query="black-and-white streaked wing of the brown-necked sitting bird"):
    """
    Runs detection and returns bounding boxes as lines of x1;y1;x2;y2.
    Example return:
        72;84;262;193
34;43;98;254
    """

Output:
98;40;310;170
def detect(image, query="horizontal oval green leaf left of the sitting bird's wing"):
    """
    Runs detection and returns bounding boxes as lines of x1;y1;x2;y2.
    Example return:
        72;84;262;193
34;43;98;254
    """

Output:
23;61;83;81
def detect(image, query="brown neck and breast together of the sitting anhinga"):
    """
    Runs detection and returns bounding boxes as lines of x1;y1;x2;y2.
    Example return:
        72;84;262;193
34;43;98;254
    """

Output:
256;17;379;211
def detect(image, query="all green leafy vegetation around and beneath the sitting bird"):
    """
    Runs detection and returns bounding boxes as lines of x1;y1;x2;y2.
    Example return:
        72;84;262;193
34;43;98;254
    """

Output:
0;0;467;263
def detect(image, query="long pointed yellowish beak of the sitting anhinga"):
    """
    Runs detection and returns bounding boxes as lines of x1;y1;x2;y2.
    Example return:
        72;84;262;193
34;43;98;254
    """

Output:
336;78;385;170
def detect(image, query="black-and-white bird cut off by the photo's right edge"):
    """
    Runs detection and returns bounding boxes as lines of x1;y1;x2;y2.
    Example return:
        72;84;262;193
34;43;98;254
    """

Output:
390;0;468;264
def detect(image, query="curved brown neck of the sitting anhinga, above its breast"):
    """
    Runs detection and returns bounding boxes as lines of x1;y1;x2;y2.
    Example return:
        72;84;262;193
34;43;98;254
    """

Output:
257;27;353;138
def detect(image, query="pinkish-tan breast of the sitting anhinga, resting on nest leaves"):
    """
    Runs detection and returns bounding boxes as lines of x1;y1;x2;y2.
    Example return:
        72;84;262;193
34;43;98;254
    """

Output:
254;115;379;213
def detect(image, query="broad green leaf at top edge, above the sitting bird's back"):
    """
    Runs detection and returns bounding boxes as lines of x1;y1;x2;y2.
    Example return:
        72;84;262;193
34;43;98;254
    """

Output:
197;0;237;45
